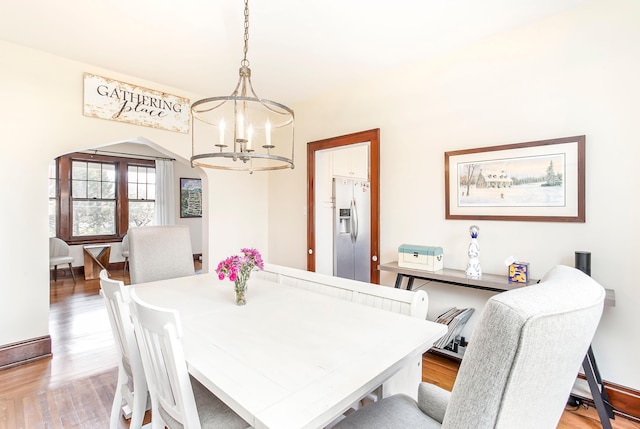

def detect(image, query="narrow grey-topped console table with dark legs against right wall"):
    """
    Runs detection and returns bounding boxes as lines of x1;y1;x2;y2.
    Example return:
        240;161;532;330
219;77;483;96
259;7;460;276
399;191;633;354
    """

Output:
378;261;616;429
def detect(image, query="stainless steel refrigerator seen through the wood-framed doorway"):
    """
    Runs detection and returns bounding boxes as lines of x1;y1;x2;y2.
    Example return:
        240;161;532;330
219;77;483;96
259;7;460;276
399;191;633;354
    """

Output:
333;177;371;282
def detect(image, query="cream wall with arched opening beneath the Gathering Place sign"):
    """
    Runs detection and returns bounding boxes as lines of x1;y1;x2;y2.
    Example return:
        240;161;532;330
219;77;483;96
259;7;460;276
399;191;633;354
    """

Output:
0;41;268;345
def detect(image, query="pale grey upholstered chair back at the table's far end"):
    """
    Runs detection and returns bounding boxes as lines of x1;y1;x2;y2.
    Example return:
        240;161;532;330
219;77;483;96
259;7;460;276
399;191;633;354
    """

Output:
127;225;195;284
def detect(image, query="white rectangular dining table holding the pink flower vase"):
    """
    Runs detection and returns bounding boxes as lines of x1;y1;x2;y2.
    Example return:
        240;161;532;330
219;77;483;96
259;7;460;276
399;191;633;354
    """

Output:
133;274;446;429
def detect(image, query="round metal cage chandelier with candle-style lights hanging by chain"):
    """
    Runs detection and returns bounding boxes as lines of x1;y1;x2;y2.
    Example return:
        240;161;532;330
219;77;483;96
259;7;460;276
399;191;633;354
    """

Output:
191;0;294;173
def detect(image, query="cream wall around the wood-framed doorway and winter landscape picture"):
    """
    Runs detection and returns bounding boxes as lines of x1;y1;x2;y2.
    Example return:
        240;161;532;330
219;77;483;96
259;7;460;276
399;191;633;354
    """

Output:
269;0;640;389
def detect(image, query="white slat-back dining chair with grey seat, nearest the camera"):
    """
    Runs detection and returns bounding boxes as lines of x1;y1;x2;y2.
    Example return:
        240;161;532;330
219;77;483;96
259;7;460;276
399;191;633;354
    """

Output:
131;290;251;429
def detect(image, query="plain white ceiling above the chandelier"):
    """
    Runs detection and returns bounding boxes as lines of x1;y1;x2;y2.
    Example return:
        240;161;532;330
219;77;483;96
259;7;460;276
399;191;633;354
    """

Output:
0;0;586;104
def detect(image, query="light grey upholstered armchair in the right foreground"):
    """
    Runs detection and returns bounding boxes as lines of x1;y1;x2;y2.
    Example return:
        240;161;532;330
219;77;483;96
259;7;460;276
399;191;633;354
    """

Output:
334;266;605;429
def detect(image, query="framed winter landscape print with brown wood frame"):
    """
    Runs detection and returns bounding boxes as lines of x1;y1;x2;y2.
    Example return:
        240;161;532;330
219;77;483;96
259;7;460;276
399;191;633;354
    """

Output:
444;136;585;222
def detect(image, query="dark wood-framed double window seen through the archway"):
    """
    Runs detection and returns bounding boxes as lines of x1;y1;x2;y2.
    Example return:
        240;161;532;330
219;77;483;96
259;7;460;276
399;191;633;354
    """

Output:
54;153;155;244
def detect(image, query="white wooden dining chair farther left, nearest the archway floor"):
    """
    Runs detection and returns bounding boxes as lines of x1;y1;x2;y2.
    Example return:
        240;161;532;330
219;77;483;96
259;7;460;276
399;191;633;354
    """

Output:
100;270;149;429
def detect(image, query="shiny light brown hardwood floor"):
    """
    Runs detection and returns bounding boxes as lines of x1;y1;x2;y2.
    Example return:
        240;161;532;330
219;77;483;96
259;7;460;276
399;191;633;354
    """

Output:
0;271;640;429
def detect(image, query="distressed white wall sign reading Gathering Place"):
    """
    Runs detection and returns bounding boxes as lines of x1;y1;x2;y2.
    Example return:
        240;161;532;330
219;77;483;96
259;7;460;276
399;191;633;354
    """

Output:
83;73;191;133
